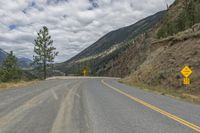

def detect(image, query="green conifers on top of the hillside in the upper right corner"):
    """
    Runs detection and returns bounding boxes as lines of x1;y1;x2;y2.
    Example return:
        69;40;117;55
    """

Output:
157;0;200;38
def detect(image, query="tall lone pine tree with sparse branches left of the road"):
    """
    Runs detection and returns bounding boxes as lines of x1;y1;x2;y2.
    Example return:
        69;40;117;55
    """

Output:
33;26;58;79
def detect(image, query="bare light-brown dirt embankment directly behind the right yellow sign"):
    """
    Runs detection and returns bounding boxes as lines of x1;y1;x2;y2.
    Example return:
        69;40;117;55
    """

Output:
127;25;200;90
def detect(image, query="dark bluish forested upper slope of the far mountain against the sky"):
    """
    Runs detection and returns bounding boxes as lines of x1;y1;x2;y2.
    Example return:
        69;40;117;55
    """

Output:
66;11;165;61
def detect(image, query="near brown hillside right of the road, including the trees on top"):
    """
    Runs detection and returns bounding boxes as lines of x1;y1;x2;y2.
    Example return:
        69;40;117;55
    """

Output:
99;0;200;95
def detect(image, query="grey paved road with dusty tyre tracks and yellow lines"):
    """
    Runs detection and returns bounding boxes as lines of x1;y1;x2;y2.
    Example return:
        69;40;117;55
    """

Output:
0;78;200;133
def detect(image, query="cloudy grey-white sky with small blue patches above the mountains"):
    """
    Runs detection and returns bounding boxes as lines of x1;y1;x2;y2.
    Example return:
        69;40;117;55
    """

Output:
0;0;174;62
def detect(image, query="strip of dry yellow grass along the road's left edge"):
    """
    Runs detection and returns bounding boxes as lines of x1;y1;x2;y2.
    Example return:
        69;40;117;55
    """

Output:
0;80;39;89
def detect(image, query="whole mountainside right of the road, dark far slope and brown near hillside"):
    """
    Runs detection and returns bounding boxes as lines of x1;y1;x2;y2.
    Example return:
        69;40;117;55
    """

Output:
56;0;200;98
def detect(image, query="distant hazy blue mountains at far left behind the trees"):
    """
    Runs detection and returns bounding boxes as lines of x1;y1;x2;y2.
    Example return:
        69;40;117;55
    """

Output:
0;49;32;69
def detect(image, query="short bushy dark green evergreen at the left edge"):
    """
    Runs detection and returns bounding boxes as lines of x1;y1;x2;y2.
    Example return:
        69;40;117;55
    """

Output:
0;51;22;82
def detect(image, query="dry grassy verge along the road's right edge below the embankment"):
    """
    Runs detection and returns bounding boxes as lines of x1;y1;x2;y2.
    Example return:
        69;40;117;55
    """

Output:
119;80;200;104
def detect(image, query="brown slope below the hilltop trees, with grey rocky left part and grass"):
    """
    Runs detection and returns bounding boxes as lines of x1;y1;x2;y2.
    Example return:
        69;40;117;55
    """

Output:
104;24;200;102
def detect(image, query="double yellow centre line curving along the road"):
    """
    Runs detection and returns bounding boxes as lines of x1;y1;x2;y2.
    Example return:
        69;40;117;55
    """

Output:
101;80;200;132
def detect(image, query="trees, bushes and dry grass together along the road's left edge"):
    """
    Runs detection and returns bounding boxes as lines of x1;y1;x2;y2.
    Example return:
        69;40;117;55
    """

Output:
0;26;58;88
